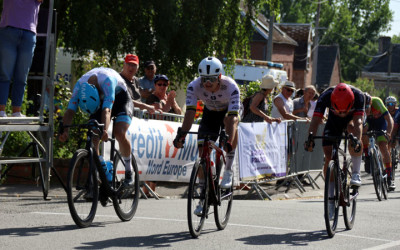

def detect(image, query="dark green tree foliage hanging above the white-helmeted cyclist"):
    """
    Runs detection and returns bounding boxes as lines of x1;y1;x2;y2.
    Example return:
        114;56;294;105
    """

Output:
56;0;279;88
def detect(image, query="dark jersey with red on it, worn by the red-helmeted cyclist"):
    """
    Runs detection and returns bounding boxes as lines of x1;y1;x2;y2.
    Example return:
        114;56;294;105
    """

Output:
313;85;365;120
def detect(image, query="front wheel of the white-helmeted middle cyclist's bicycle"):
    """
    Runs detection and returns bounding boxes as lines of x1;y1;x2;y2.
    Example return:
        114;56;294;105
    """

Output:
187;160;209;238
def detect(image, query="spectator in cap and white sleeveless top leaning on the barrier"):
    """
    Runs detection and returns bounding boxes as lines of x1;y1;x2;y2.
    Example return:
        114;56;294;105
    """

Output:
271;81;307;120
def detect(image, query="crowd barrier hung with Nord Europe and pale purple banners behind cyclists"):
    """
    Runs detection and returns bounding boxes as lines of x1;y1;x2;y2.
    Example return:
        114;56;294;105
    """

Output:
105;109;323;199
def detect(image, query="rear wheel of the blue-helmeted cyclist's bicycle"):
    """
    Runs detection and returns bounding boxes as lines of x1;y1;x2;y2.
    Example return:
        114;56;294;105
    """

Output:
113;152;140;221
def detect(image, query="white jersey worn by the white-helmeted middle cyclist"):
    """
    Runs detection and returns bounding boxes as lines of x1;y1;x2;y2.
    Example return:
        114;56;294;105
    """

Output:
186;75;240;114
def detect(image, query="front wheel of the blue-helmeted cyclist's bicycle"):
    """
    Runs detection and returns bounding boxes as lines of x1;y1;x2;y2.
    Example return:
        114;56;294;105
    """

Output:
67;149;99;227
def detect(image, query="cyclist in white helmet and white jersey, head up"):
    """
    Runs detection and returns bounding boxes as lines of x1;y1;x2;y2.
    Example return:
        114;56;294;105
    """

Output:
174;57;240;215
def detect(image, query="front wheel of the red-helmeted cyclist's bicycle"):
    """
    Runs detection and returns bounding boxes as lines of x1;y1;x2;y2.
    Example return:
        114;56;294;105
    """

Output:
324;161;340;238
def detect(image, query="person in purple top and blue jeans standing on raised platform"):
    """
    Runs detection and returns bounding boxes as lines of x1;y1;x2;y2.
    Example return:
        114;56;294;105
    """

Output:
0;0;43;117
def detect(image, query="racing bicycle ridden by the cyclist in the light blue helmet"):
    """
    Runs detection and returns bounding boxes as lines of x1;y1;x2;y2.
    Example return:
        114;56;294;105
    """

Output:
60;119;139;228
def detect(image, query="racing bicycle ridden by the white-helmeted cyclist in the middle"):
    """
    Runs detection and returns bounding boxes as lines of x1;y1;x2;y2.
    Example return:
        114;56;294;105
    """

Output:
178;128;233;238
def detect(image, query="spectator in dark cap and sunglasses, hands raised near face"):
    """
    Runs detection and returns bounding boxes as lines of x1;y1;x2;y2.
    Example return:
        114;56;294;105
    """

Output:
146;75;182;115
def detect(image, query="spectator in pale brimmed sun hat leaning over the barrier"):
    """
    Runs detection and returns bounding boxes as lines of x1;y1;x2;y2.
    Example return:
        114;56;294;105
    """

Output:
242;75;281;123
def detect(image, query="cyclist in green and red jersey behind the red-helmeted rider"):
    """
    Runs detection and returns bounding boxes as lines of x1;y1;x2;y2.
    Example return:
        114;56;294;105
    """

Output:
362;94;393;180
